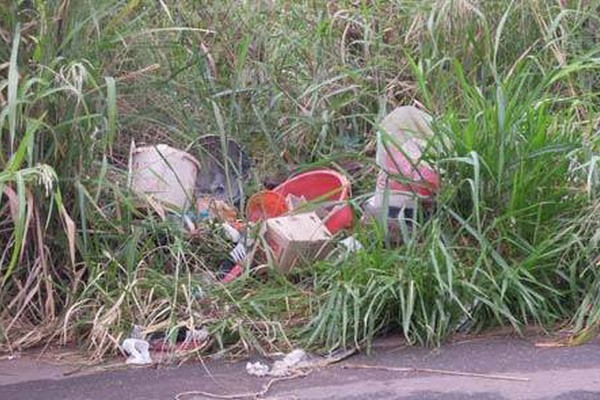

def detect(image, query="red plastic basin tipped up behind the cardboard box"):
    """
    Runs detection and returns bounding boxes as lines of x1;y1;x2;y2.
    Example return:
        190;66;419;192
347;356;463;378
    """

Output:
273;169;353;234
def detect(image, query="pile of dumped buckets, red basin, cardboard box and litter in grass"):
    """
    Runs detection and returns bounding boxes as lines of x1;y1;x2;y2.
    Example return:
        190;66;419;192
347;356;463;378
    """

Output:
123;107;440;361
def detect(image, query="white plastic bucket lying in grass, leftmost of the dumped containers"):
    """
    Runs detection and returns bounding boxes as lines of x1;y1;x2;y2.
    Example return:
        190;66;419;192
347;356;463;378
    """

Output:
131;144;200;210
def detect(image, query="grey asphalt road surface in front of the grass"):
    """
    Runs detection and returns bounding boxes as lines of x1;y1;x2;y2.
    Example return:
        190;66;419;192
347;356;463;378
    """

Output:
0;336;600;400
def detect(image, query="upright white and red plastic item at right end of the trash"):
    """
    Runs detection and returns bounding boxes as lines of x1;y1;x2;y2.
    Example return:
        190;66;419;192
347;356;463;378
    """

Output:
373;106;440;209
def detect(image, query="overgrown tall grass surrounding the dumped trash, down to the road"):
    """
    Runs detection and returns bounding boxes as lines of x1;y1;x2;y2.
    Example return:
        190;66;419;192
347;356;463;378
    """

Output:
0;0;600;358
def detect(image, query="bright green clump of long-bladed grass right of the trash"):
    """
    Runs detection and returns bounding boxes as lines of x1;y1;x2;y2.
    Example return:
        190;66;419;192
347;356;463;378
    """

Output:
309;51;596;347
